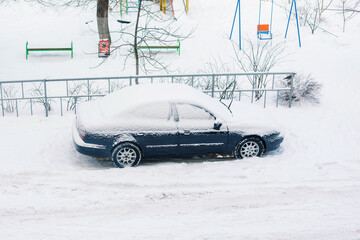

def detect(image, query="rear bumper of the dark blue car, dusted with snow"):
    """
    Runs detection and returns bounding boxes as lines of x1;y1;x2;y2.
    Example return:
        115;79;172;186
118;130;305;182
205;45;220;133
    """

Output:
72;123;109;158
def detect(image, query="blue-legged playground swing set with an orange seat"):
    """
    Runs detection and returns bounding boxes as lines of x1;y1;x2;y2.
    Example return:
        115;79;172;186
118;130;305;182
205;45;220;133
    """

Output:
230;0;301;50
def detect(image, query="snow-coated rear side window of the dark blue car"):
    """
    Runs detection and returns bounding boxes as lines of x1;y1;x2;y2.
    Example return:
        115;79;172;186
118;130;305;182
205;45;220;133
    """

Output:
129;103;172;120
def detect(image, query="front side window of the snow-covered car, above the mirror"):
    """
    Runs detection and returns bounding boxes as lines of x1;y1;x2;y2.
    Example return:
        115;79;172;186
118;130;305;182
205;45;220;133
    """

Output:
176;103;215;120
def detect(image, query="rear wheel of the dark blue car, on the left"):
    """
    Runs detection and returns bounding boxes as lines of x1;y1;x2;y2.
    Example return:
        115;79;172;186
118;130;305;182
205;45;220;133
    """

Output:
111;143;141;168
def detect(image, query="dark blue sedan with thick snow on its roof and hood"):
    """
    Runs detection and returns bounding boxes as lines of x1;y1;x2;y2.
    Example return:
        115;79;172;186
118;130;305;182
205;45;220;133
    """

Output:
73;84;283;167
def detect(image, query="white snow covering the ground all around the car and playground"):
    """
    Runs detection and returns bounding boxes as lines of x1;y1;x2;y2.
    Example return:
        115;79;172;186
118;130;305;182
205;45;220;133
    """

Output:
0;0;360;240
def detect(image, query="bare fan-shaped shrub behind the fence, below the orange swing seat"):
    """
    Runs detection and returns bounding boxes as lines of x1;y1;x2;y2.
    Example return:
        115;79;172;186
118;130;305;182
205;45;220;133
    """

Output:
233;38;285;100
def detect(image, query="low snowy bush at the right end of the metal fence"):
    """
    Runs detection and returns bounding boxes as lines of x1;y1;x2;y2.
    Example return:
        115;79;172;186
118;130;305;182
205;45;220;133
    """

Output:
279;74;322;105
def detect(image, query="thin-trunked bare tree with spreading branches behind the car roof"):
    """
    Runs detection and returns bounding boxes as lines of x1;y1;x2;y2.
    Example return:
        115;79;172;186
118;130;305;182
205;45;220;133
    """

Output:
113;0;193;81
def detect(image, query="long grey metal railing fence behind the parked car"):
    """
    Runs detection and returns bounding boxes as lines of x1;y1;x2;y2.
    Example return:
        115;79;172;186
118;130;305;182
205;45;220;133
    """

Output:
0;72;295;117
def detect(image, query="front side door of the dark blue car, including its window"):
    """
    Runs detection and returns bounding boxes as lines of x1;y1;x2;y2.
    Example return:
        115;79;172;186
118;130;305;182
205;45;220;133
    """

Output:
175;103;228;155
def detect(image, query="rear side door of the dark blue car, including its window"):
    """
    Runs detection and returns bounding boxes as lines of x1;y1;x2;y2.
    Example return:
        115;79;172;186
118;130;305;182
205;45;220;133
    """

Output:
129;102;179;156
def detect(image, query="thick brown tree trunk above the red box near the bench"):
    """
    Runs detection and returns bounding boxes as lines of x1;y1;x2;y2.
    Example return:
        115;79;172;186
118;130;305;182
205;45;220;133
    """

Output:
96;0;111;43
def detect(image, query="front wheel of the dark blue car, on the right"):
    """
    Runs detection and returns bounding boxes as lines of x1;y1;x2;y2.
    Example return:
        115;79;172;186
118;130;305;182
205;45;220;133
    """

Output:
235;137;265;159
